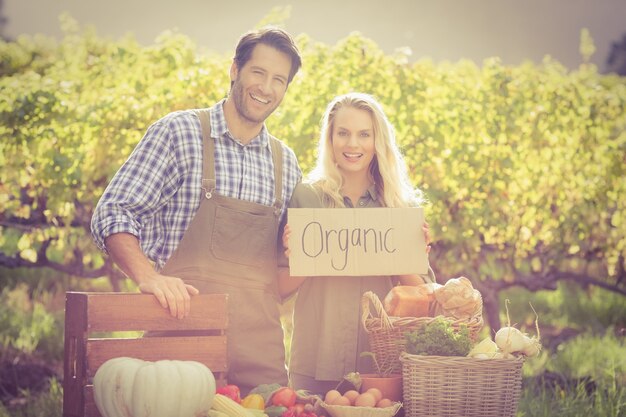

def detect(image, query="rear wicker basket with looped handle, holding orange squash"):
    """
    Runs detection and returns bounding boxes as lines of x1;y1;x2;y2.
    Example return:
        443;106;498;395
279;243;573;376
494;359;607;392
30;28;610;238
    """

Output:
361;291;483;373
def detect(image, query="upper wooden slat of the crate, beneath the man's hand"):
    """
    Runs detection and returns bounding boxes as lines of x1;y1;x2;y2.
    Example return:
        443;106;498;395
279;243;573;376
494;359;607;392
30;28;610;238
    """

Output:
87;293;228;332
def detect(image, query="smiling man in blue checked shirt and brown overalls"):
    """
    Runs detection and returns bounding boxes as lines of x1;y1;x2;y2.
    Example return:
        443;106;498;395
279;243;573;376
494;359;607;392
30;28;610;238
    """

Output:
91;28;302;392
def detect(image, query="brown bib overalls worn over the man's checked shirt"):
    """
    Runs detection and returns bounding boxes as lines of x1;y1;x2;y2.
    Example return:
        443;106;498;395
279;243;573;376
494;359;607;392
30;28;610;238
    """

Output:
162;110;287;393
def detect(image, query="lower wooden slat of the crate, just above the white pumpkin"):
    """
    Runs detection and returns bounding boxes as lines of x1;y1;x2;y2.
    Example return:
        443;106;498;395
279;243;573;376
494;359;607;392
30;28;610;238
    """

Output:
86;336;228;377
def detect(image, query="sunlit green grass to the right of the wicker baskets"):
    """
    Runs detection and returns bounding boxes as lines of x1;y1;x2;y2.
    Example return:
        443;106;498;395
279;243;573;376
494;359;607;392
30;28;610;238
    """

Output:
501;283;626;417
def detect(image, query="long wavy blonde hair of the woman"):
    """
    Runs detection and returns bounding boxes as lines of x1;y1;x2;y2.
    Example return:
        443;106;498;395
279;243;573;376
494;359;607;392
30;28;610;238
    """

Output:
309;93;424;207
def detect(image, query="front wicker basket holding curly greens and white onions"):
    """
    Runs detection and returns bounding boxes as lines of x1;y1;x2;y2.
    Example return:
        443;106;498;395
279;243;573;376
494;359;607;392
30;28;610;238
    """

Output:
400;352;524;417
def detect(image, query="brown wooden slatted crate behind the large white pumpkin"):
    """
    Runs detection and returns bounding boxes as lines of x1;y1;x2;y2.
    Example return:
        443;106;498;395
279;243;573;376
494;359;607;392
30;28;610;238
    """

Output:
63;292;228;417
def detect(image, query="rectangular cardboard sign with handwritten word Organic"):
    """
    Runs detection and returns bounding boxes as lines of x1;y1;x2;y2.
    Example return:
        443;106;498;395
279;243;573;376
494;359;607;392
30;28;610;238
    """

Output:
288;208;428;276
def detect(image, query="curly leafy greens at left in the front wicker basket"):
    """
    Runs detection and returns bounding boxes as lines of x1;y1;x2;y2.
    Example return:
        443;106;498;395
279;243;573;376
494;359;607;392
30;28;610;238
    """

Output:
405;317;472;356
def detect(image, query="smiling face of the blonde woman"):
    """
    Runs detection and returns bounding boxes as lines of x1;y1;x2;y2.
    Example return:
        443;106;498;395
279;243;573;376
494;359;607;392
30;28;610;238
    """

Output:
331;107;375;176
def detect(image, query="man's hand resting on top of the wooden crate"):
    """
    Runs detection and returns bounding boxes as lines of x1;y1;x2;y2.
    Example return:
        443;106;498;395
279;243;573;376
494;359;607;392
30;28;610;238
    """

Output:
139;272;200;319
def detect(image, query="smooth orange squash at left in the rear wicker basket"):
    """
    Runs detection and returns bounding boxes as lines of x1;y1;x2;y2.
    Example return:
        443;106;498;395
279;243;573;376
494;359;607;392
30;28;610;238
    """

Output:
383;284;436;317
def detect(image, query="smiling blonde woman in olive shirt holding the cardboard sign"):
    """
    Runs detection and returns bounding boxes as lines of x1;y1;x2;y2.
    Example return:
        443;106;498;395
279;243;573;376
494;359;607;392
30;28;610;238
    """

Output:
279;93;434;394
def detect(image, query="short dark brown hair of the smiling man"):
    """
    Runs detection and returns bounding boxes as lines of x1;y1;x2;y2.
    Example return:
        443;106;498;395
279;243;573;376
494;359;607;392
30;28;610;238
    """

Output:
234;27;302;83
